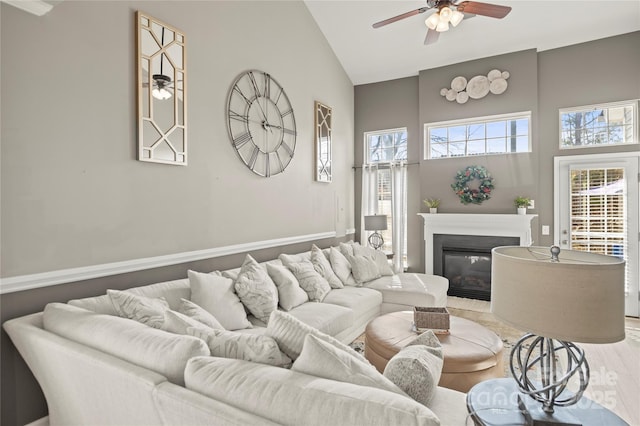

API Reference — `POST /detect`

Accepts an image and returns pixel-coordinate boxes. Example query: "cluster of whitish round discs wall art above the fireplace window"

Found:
[440,69,510,104]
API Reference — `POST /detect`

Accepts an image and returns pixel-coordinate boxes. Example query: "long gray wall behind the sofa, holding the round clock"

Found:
[0,1,354,425]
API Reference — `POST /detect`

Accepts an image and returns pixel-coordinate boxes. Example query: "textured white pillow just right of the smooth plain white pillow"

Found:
[234,254,278,323]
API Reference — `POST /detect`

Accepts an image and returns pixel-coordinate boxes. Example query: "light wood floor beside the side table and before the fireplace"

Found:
[448,297,640,426]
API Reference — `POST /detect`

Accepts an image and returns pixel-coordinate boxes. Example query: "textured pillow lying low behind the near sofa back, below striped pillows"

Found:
[187,327,291,368]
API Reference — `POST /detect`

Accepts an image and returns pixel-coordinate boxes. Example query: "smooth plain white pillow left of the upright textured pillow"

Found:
[188,271,252,330]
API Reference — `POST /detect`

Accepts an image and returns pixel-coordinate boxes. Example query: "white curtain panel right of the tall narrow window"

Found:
[391,161,407,272]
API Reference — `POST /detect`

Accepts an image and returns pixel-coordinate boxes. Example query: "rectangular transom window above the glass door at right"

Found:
[560,101,638,149]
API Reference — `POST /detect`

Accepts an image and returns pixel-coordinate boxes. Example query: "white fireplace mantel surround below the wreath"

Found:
[418,213,538,274]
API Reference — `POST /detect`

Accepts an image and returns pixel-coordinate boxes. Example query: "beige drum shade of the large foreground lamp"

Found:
[491,246,625,343]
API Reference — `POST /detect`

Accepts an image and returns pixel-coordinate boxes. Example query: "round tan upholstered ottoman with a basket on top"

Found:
[364,311,504,392]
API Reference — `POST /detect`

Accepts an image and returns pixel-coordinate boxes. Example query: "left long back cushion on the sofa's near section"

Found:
[43,303,209,385]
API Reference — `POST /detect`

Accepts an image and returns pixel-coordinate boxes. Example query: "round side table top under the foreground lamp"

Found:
[467,378,629,426]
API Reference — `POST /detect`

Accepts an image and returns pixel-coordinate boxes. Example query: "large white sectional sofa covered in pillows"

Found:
[4,243,467,425]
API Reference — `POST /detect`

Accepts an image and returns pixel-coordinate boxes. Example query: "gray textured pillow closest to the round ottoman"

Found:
[383,331,443,405]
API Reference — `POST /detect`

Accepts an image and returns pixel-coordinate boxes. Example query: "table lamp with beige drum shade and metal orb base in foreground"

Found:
[491,246,625,424]
